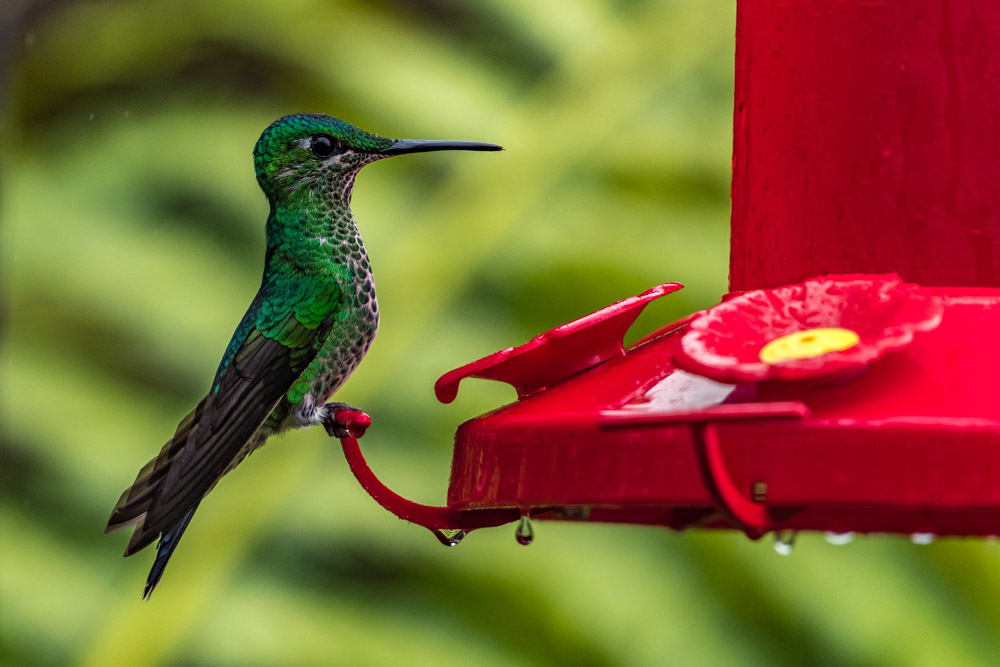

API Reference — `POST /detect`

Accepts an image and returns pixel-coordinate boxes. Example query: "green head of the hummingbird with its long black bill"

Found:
[253,113,502,201]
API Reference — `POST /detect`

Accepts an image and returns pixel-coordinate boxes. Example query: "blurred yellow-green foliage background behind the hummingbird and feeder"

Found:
[0,0,1000,666]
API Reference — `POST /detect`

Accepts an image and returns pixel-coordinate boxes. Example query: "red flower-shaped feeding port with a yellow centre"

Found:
[674,274,943,384]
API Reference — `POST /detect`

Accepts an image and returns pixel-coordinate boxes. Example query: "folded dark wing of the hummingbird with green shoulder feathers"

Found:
[106,282,339,556]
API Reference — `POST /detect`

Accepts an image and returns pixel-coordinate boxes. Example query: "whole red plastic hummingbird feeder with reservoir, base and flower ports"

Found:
[344,0,1000,543]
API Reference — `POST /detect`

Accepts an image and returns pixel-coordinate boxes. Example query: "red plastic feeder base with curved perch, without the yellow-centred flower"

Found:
[342,285,1000,537]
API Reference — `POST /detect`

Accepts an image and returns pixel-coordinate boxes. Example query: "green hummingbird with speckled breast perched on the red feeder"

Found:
[105,114,502,598]
